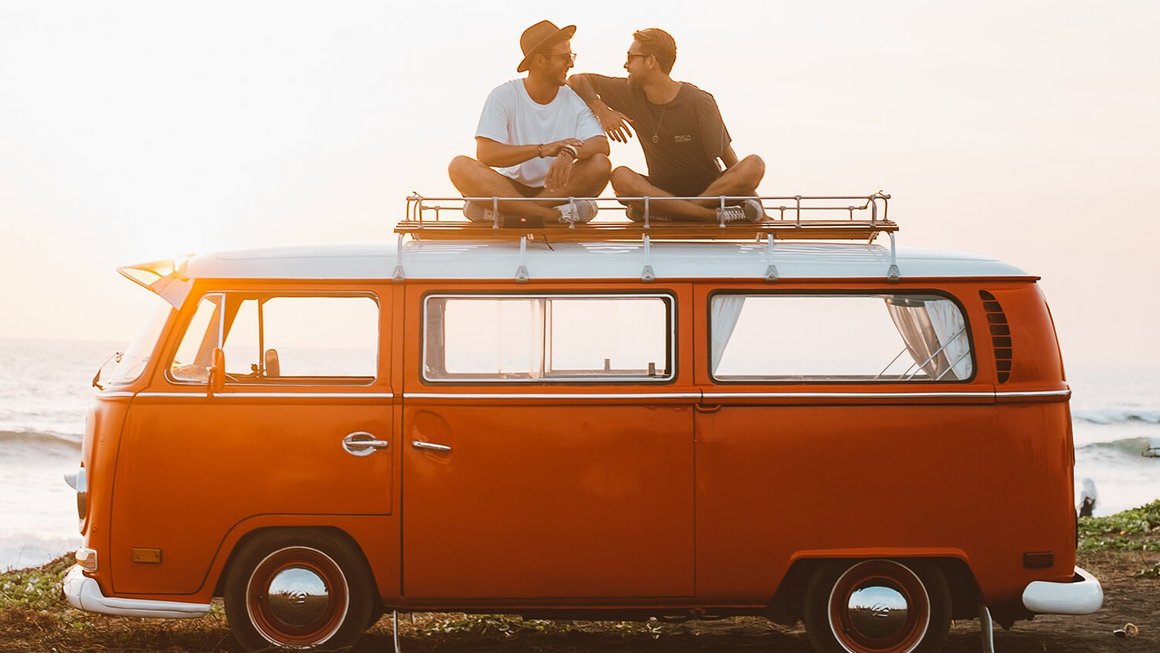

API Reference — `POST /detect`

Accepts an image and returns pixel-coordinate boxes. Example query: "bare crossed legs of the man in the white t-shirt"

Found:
[447,154,612,219]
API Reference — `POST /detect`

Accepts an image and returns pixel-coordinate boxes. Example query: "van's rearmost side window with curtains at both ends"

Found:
[710,293,974,383]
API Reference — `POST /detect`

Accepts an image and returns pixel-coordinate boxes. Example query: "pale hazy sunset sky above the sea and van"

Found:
[0,0,1160,367]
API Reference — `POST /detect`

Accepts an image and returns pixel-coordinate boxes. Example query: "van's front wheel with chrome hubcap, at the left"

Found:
[225,530,376,651]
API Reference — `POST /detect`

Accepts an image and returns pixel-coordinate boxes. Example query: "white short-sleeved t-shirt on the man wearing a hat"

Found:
[476,78,604,187]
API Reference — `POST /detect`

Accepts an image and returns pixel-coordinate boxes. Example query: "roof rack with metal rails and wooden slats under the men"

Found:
[394,190,898,247]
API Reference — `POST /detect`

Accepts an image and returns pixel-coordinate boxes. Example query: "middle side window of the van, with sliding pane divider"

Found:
[423,295,674,382]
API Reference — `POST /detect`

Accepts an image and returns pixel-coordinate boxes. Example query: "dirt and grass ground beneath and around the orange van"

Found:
[0,551,1160,653]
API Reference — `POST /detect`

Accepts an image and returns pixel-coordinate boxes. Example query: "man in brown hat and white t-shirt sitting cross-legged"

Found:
[448,21,611,223]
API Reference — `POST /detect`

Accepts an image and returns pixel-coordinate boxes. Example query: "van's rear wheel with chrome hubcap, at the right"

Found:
[802,559,951,653]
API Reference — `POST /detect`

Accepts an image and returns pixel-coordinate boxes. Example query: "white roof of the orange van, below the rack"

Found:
[177,240,1035,280]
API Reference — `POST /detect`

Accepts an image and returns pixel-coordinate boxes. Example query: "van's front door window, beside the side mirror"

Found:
[169,292,378,384]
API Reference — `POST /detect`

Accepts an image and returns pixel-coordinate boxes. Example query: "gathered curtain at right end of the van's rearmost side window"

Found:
[886,297,971,380]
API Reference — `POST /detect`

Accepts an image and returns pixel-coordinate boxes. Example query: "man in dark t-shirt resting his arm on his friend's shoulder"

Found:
[568,28,766,222]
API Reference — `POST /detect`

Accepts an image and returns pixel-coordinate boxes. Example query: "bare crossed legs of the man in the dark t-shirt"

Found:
[612,154,766,222]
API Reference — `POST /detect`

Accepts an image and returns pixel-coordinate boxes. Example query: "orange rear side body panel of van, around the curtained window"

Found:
[682,281,1074,603]
